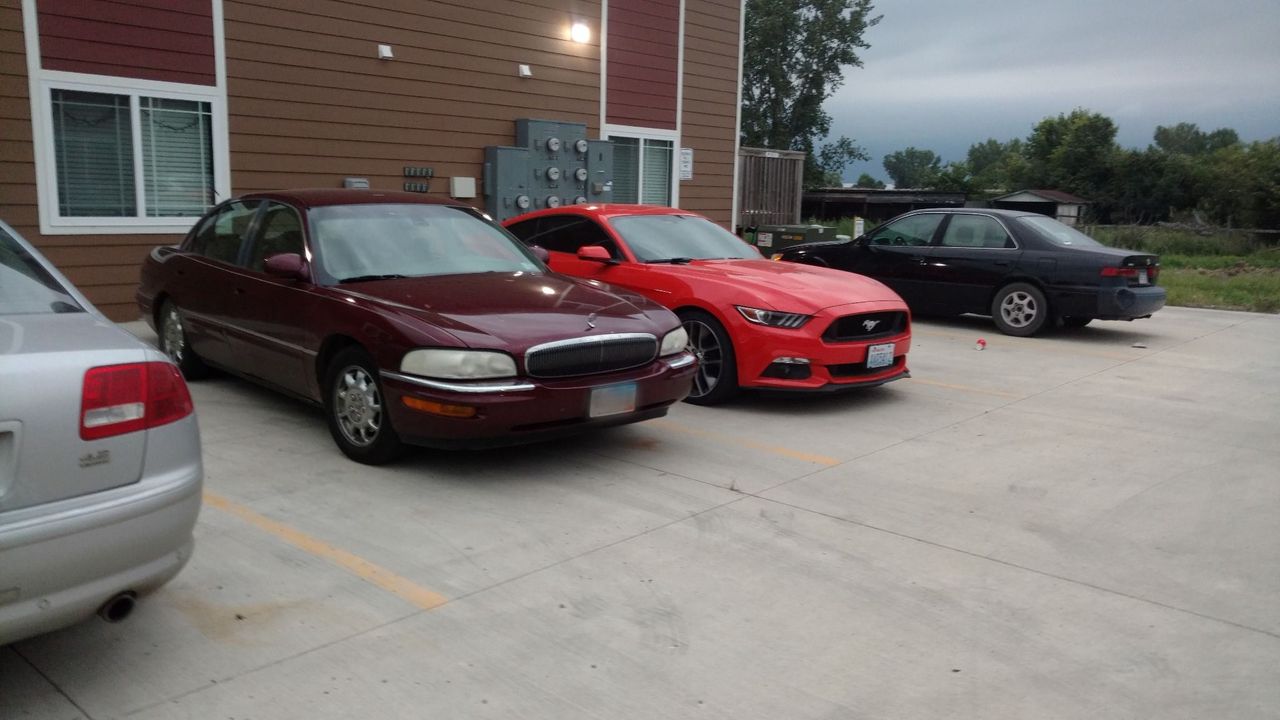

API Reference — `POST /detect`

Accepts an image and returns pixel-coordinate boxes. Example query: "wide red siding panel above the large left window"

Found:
[36,0,216,85]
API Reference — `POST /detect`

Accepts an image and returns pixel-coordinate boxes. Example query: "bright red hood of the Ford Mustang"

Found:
[654,260,905,313]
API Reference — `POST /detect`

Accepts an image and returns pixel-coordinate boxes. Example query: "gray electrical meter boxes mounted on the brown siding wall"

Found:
[484,119,613,220]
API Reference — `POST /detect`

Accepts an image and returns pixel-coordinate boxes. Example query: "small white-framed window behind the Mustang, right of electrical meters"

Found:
[605,126,680,206]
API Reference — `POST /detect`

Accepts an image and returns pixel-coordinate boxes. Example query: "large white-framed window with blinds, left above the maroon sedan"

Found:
[32,72,230,234]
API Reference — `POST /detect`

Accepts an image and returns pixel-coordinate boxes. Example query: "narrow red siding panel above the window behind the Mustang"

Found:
[605,0,680,129]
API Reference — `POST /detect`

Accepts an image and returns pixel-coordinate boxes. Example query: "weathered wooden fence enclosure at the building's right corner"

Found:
[735,147,805,228]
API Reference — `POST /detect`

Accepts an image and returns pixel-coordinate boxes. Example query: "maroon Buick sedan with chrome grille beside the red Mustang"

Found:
[137,190,695,464]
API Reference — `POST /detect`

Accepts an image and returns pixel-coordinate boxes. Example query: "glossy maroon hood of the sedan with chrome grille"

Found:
[333,273,680,354]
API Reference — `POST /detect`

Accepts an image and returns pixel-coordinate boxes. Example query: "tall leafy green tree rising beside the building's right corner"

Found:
[742,0,879,187]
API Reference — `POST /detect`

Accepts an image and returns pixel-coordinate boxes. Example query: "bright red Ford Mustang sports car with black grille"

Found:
[504,205,911,405]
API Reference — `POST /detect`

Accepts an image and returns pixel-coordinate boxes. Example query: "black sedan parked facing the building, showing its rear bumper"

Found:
[773,209,1165,337]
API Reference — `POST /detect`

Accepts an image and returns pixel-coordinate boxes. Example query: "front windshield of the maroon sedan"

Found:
[311,204,545,282]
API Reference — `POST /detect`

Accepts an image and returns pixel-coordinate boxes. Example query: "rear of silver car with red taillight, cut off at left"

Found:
[0,223,204,646]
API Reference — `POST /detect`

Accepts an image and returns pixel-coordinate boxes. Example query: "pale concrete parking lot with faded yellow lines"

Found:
[0,307,1280,720]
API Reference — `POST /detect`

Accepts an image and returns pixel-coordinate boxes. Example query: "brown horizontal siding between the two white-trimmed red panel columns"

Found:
[225,0,600,193]
